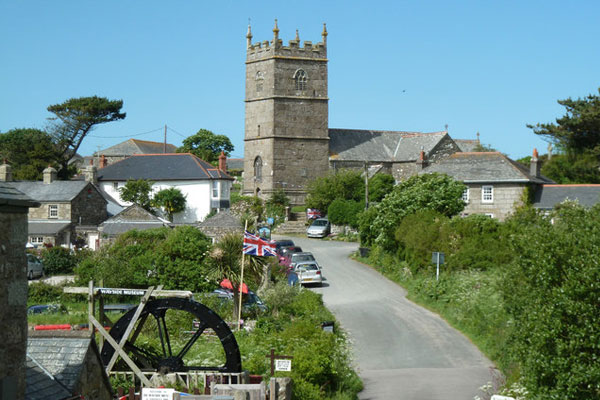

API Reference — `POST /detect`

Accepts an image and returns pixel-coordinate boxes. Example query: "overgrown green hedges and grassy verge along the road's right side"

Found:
[358,203,600,399]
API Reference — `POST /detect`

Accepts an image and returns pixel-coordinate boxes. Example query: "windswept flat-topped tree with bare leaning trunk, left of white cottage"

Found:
[48,96,126,178]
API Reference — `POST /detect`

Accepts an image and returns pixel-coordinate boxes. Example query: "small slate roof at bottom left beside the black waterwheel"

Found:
[27,331,92,399]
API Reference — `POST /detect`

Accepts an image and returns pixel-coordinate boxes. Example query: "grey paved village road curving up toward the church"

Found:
[284,237,493,400]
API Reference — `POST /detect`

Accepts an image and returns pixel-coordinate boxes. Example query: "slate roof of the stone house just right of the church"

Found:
[421,152,553,184]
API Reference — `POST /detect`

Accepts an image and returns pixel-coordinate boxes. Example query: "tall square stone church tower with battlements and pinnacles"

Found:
[243,20,329,204]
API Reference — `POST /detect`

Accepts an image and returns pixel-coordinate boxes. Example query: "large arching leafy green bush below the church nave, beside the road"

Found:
[360,173,466,250]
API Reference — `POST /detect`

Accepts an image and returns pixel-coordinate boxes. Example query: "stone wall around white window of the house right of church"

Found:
[463,183,526,221]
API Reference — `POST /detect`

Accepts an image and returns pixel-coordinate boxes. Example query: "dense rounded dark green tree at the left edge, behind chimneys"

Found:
[0,129,59,181]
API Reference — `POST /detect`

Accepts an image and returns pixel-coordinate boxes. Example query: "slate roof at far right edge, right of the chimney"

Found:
[533,185,600,210]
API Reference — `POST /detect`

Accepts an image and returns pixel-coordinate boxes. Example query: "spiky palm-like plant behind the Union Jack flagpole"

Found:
[210,233,269,319]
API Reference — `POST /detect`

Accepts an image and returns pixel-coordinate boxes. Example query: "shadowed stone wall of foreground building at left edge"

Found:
[0,206,27,400]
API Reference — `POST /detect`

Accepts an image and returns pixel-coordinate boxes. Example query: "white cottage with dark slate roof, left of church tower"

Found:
[98,153,233,224]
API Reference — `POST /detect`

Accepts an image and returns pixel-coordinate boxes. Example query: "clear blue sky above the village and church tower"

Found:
[0,0,600,158]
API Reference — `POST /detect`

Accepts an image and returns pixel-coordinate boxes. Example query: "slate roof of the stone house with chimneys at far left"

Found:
[4,181,89,202]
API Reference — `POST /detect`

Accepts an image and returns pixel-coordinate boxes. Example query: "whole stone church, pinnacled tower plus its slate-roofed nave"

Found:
[243,20,472,204]
